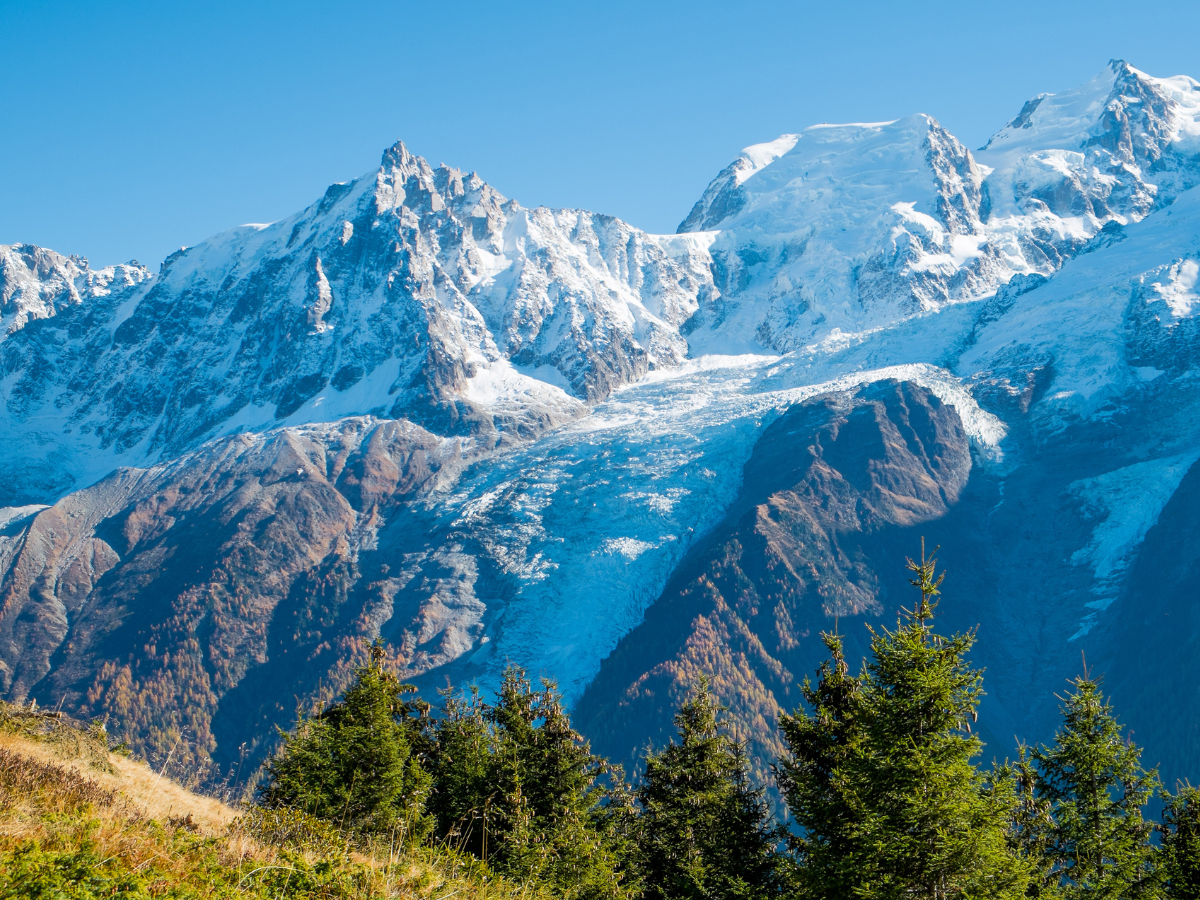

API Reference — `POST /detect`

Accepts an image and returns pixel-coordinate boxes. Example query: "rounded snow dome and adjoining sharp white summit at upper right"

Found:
[679,61,1200,353]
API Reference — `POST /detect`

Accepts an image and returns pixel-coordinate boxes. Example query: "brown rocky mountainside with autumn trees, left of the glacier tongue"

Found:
[0,419,478,764]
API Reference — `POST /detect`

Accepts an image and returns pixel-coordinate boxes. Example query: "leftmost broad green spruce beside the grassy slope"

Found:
[262,642,432,841]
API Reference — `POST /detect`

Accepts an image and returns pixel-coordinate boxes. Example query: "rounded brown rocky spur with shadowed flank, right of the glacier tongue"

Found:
[577,382,971,764]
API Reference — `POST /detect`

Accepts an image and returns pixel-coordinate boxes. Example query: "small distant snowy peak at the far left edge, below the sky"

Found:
[0,244,150,341]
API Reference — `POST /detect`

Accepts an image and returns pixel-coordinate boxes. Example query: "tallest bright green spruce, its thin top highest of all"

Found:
[863,547,1027,899]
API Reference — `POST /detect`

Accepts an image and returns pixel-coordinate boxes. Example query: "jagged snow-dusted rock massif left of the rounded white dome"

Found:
[0,144,710,502]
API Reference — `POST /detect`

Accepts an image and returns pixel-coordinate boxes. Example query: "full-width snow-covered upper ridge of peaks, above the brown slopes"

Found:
[7,62,1200,508]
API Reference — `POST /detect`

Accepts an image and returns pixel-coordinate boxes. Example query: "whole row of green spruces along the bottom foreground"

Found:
[259,550,1200,900]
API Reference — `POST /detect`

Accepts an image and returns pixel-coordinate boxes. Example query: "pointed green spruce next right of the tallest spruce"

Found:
[1032,674,1158,900]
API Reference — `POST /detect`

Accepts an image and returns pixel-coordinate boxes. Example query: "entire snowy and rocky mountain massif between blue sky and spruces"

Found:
[0,61,1200,780]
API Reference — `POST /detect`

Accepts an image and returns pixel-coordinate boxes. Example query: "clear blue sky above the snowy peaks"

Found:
[7,0,1200,268]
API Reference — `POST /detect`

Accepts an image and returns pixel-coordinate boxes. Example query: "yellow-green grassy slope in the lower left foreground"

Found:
[0,704,539,900]
